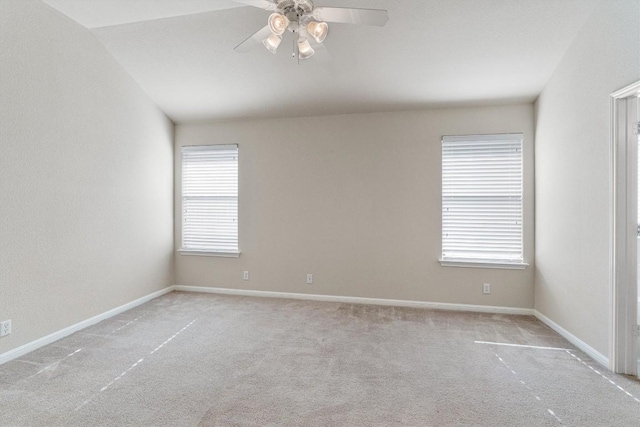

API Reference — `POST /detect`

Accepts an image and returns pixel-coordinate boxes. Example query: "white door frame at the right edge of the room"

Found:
[609,81,640,375]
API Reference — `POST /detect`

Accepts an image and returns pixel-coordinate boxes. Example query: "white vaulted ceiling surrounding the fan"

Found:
[44,0,599,123]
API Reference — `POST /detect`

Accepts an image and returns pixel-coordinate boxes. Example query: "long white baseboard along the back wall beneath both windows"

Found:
[173,285,533,316]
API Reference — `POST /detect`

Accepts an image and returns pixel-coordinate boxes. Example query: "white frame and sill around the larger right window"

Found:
[438,133,529,270]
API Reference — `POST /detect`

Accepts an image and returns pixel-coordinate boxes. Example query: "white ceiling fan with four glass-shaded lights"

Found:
[235,0,389,60]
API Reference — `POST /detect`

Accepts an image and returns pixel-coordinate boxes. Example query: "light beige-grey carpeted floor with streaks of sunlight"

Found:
[0,292,640,427]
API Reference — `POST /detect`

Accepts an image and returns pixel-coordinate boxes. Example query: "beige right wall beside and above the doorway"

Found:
[535,0,640,355]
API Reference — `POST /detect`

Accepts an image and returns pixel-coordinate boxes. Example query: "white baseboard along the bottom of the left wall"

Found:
[0,286,174,365]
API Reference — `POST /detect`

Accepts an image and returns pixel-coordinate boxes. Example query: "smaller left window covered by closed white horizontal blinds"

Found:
[180,145,240,256]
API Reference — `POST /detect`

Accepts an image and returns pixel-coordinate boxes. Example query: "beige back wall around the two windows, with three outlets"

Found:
[175,105,533,308]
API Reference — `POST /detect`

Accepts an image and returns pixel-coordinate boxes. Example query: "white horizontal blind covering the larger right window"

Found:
[442,134,523,263]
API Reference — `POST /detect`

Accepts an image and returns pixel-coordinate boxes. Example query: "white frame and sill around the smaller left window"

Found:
[178,144,241,258]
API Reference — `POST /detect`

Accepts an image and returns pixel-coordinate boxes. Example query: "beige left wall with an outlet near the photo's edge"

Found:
[0,0,173,354]
